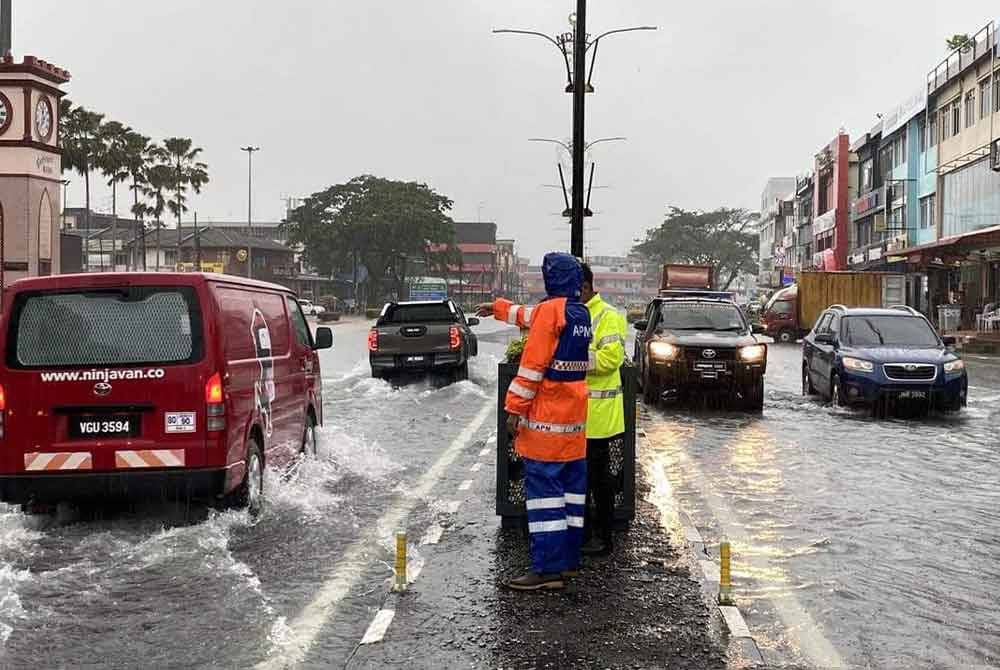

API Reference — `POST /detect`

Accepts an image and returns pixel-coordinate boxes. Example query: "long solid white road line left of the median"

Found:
[257,401,493,670]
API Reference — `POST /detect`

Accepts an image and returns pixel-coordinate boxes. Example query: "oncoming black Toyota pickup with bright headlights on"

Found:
[635,291,767,412]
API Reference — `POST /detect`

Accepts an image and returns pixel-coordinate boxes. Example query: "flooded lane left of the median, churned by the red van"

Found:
[0,322,516,668]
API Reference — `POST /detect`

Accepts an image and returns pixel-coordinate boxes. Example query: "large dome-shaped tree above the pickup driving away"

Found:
[285,175,455,306]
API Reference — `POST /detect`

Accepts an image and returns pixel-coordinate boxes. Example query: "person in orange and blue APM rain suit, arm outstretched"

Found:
[477,253,591,591]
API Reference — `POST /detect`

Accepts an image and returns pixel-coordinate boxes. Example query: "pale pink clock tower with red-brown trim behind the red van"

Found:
[0,54,69,287]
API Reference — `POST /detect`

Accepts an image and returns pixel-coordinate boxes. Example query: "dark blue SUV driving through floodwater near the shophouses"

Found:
[802,305,969,412]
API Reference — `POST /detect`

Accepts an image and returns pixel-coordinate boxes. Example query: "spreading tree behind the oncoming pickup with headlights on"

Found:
[634,206,759,291]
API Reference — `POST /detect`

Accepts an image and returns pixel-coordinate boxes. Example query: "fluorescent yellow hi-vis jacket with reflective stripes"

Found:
[587,295,626,439]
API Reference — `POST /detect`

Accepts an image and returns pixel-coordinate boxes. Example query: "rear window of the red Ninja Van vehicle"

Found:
[7,286,202,368]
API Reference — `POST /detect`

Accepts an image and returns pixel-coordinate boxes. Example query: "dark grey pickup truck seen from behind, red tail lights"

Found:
[368,300,479,381]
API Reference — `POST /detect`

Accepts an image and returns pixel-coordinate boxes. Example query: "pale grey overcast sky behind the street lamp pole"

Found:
[19,0,1000,266]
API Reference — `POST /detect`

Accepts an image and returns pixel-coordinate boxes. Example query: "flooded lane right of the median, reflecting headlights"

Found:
[641,345,1000,669]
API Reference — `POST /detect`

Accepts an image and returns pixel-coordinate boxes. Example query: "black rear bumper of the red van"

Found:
[0,468,226,505]
